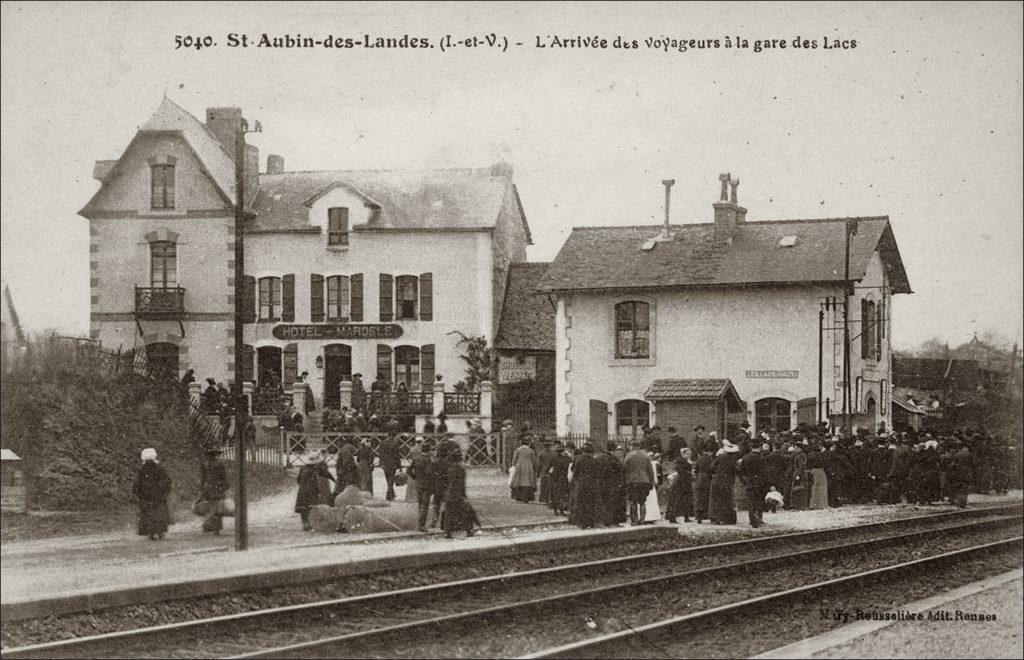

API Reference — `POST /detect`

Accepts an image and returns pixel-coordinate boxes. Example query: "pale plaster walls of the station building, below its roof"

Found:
[555,252,892,435]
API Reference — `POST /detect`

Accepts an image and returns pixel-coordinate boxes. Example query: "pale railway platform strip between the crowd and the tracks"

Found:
[0,478,1021,612]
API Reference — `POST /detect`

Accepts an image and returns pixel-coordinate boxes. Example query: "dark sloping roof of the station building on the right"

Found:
[539,216,910,294]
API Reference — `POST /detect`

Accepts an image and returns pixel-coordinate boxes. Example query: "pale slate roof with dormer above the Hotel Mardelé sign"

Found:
[247,168,529,235]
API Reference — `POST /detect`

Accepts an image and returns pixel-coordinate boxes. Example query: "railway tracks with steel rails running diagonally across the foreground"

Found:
[2,504,1021,658]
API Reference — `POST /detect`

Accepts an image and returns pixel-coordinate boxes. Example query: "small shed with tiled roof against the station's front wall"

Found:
[644,379,746,438]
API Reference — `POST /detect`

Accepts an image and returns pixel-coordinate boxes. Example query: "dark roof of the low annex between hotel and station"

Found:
[495,263,555,351]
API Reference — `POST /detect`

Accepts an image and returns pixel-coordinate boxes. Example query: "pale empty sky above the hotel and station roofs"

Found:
[0,2,1024,349]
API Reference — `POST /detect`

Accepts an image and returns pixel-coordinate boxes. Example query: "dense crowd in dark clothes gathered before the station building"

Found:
[501,423,1020,528]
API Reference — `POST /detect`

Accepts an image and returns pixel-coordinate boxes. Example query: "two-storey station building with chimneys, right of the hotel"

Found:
[539,175,911,438]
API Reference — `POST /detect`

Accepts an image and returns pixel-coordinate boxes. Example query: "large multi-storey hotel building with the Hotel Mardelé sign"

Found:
[80,98,530,406]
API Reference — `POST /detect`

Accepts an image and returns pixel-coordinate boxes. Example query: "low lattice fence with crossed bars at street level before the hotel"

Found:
[282,431,506,466]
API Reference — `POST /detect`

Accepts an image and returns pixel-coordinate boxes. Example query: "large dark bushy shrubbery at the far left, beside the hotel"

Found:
[0,343,211,511]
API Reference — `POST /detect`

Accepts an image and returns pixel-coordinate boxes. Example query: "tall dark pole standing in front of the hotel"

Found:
[231,119,261,551]
